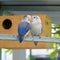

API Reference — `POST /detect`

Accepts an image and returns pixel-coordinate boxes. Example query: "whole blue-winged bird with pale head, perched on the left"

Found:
[18,15,31,43]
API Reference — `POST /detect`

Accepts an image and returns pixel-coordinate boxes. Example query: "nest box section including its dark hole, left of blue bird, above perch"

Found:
[0,16,23,34]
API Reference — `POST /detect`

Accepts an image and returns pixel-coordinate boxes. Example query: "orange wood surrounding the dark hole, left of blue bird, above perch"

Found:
[0,16,21,34]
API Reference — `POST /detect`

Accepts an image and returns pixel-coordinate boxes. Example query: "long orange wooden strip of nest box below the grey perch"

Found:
[0,40,52,49]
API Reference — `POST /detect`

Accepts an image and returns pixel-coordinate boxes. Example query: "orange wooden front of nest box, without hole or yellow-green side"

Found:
[0,14,52,49]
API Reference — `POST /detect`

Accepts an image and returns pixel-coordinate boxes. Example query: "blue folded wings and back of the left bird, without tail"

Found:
[18,22,30,35]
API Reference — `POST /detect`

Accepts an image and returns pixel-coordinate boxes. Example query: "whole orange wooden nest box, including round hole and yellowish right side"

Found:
[0,14,52,49]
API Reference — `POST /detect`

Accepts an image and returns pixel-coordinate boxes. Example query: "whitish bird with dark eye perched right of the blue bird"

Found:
[31,15,42,46]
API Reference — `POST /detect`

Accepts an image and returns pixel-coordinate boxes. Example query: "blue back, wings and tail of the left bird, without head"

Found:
[18,22,30,43]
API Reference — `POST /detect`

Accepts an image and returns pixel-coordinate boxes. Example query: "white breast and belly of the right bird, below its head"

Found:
[31,23,42,36]
